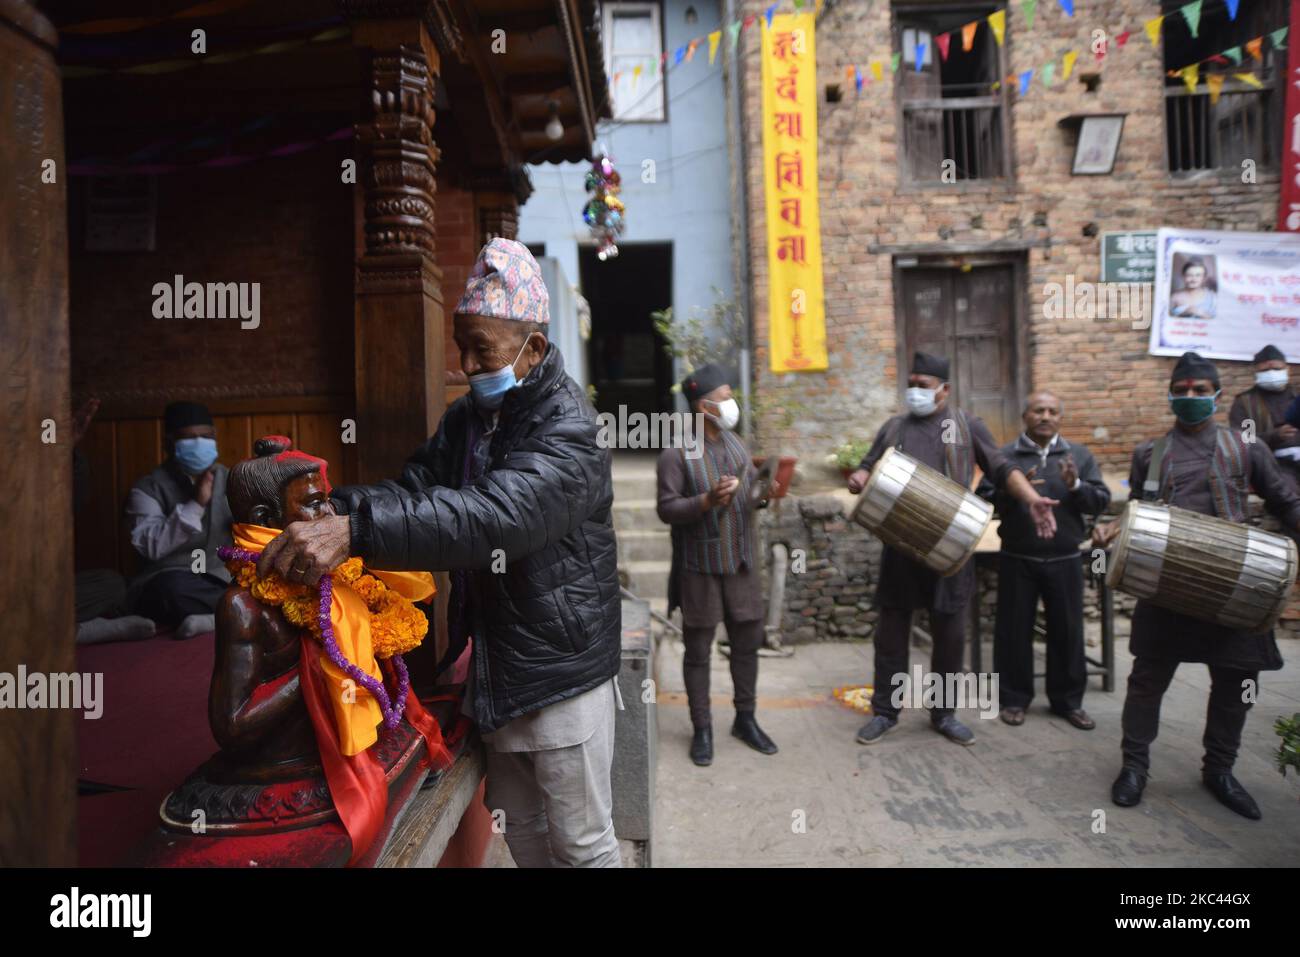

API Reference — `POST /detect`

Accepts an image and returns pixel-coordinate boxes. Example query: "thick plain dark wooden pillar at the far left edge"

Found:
[0,0,76,867]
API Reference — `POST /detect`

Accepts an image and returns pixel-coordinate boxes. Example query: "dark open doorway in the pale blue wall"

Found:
[579,243,672,416]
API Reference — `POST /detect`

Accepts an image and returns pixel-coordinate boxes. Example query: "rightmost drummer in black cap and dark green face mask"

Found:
[1093,352,1300,820]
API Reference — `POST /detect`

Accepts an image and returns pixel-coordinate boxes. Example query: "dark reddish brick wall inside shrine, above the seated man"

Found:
[69,143,354,407]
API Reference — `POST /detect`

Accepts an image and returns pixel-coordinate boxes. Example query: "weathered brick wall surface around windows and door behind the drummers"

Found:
[742,0,1278,468]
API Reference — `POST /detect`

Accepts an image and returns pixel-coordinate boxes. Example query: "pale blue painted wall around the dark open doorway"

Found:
[519,0,732,397]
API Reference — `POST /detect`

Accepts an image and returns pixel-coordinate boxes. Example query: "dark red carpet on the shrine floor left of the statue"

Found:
[77,633,217,867]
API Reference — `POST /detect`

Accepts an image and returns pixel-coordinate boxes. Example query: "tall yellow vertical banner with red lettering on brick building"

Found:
[763,10,827,372]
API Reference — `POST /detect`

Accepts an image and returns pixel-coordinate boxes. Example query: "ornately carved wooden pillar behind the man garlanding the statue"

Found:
[343,11,446,481]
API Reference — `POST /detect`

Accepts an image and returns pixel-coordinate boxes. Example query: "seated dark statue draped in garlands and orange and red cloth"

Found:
[161,436,450,861]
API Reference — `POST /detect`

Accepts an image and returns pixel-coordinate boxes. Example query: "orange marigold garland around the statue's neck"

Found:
[226,558,429,659]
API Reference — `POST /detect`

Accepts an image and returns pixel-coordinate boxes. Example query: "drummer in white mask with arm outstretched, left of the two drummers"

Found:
[849,352,1060,745]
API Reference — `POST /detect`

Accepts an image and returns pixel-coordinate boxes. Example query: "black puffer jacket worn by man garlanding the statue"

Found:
[334,345,621,731]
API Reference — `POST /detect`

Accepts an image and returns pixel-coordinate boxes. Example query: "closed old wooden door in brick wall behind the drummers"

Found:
[900,264,1021,443]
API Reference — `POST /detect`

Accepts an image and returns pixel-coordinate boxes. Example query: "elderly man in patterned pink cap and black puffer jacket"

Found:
[259,239,621,867]
